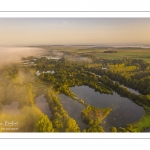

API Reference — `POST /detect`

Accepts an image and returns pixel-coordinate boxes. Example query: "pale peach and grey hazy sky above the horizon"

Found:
[0,18,150,46]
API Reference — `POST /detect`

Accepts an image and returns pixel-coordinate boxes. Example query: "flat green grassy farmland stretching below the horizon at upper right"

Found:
[41,46,150,63]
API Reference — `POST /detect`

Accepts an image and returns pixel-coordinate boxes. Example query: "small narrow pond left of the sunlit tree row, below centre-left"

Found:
[36,94,52,118]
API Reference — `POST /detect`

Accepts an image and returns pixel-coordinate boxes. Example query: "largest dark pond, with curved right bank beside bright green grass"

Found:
[68,86,144,132]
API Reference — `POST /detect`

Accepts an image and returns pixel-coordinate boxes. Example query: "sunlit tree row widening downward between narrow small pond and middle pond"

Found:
[45,88,80,132]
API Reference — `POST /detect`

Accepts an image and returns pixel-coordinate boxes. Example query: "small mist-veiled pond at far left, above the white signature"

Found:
[1,101,20,115]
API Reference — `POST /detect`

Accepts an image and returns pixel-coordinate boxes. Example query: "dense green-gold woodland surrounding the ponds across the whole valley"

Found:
[0,51,150,132]
